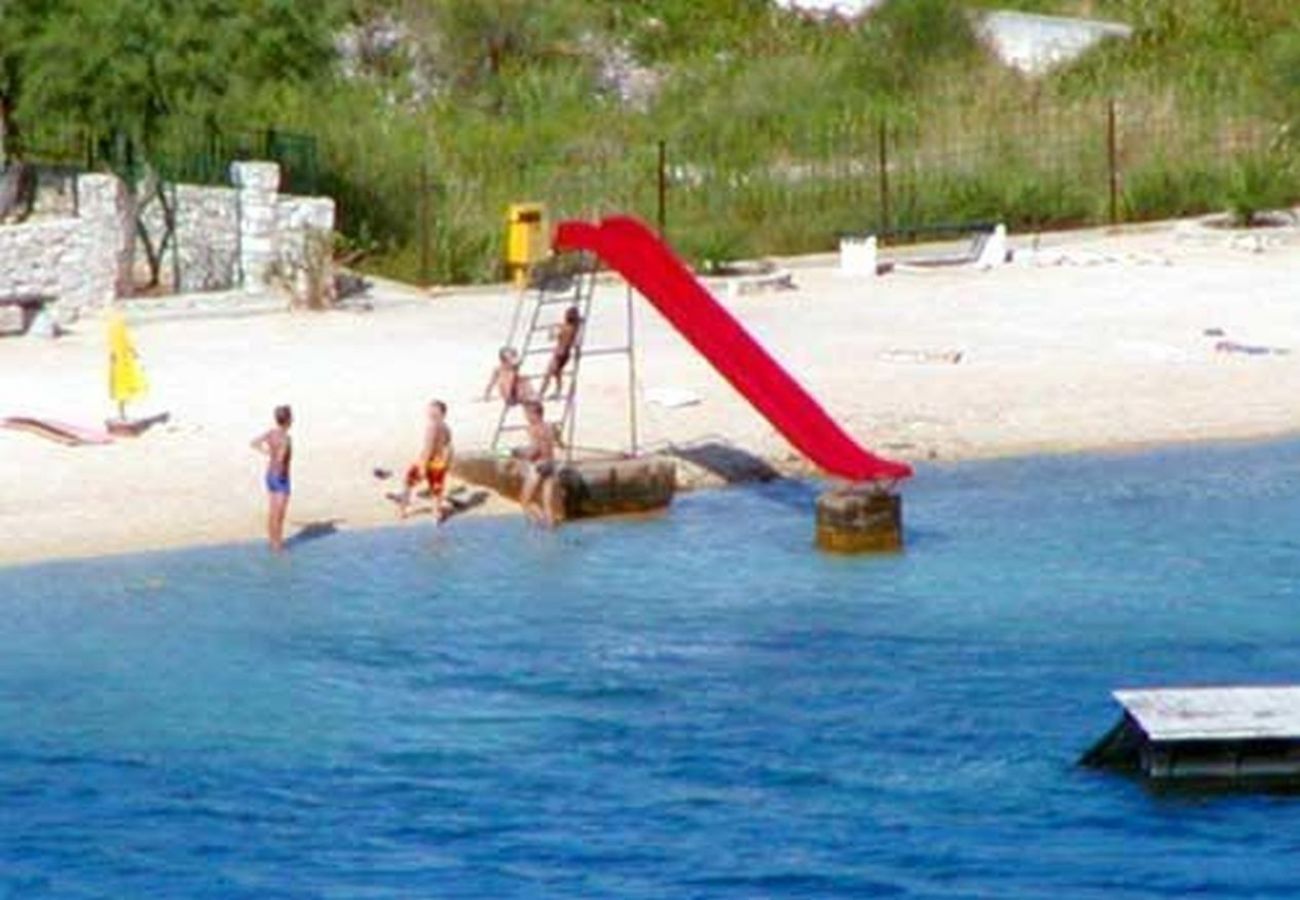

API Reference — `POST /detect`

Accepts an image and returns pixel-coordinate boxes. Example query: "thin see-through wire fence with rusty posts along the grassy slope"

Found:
[337,87,1300,282]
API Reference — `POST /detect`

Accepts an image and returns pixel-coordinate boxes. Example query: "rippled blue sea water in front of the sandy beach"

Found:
[0,443,1300,900]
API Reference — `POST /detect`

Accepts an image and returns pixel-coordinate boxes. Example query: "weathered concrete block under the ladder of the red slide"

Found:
[452,453,677,520]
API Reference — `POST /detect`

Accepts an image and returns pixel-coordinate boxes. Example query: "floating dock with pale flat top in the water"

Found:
[1080,685,1300,786]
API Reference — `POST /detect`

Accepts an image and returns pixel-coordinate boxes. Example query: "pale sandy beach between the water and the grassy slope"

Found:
[0,222,1300,564]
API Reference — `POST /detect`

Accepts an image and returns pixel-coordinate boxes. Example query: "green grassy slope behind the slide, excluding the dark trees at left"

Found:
[278,0,1300,282]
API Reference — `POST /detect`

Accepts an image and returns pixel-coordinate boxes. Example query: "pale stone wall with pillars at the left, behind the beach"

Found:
[0,163,334,315]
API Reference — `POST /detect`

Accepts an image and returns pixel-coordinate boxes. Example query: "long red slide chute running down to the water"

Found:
[554,216,911,481]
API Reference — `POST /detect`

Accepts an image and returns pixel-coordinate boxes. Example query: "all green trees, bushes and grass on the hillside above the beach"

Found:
[0,0,1300,281]
